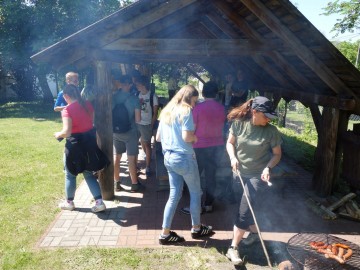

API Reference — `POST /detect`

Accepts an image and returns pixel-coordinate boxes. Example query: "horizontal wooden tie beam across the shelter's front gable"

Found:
[103,38,279,55]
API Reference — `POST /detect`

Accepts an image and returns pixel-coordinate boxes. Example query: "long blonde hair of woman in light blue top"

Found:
[160,84,199,125]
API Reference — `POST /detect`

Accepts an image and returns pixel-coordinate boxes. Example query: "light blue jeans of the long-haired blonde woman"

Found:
[162,151,202,229]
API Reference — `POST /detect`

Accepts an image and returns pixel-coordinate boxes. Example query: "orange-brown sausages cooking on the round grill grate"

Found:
[309,241,353,264]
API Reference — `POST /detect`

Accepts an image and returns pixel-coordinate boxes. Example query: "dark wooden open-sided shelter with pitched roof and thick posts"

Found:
[32,0,360,199]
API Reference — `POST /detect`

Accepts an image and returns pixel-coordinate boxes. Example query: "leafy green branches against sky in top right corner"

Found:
[324,0,360,34]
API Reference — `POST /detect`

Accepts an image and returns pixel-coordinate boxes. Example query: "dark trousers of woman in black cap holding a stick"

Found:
[234,174,266,230]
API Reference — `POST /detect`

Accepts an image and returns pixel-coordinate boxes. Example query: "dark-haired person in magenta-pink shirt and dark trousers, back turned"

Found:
[181,81,226,214]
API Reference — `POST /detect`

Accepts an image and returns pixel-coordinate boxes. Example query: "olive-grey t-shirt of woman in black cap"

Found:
[230,120,282,176]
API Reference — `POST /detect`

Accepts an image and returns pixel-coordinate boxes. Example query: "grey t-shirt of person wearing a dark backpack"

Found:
[112,90,140,130]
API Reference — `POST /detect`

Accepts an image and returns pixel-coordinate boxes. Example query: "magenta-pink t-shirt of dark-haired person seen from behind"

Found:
[193,99,226,148]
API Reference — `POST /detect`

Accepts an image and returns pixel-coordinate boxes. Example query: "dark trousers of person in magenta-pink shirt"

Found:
[194,145,224,206]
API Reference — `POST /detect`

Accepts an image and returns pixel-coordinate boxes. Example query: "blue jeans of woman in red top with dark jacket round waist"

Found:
[64,155,102,201]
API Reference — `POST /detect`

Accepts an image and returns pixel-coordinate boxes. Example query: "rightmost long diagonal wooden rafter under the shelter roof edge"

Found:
[241,0,356,98]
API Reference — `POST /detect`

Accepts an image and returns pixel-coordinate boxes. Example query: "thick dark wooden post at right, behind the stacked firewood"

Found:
[313,107,339,196]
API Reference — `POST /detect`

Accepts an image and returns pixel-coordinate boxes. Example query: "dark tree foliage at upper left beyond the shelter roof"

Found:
[0,0,121,100]
